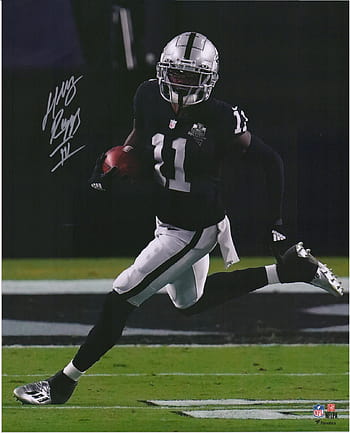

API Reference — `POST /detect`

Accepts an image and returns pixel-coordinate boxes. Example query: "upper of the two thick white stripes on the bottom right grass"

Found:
[145,398,349,404]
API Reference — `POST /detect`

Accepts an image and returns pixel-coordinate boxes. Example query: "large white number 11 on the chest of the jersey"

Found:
[152,133,191,192]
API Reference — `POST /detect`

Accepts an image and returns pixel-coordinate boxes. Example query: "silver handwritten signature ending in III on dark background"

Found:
[41,75,85,172]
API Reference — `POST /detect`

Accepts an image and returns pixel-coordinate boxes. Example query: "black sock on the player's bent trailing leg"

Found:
[179,267,268,315]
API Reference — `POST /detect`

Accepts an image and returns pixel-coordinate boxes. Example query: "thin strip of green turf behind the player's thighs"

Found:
[2,257,349,280]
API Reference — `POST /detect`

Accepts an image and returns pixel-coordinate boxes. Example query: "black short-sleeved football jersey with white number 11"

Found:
[134,80,248,230]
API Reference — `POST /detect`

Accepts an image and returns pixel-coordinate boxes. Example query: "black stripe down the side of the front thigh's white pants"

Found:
[119,230,203,299]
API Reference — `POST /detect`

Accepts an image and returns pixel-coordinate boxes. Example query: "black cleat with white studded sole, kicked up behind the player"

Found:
[277,242,344,296]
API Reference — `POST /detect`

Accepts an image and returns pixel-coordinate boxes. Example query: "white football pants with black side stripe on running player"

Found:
[113,218,238,308]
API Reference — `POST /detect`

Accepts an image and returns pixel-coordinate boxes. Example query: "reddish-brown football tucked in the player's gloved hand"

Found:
[102,146,139,178]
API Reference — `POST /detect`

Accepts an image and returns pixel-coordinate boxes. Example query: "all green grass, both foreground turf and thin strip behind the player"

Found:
[2,257,349,432]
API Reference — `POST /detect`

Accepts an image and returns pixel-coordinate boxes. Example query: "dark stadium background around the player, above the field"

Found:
[2,0,349,257]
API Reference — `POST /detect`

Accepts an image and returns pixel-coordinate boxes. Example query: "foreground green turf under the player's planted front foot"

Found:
[2,345,349,432]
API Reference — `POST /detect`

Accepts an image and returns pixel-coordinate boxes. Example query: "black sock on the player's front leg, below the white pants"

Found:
[73,290,136,371]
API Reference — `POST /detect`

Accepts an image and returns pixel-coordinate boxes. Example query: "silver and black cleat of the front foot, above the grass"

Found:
[13,371,78,405]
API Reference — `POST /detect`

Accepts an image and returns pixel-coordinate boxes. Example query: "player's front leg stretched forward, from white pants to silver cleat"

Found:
[14,221,217,405]
